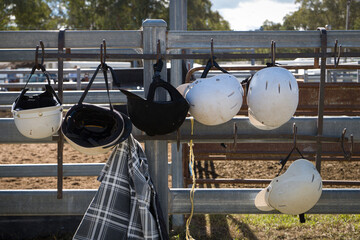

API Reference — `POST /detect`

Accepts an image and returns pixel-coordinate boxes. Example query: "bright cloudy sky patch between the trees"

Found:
[211,0,299,31]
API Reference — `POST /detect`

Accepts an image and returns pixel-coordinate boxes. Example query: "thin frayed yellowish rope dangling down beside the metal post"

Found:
[186,118,196,240]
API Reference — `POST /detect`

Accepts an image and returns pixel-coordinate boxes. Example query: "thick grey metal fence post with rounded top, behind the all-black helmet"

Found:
[143,19,169,227]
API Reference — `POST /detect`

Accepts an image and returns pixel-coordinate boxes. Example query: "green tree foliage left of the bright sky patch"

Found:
[0,0,230,30]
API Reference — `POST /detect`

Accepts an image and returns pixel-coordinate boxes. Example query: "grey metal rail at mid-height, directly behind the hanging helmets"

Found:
[0,116,360,143]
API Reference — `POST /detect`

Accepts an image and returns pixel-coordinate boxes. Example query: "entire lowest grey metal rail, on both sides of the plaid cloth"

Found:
[0,188,360,216]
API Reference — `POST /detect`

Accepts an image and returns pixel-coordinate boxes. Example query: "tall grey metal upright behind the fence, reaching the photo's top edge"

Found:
[170,0,187,227]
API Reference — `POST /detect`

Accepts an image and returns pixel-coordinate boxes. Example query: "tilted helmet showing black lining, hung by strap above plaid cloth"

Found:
[61,51,132,155]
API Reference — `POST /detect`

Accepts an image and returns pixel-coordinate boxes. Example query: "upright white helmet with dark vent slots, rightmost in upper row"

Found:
[247,67,299,130]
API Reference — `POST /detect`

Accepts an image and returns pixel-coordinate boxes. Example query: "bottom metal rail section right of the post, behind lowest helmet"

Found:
[169,188,360,214]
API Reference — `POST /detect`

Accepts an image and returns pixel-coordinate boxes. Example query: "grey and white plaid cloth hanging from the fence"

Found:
[73,135,169,240]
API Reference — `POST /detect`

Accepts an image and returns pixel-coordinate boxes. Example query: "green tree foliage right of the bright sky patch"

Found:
[261,0,360,30]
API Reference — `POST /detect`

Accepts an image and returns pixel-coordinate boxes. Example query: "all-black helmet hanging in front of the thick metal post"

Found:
[120,59,189,136]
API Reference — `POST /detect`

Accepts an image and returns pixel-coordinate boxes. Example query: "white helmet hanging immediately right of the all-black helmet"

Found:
[184,74,244,125]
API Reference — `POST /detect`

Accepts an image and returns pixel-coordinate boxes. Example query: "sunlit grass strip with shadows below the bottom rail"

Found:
[170,214,360,240]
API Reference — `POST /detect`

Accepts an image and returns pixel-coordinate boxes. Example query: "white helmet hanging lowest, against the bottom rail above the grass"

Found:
[255,159,322,215]
